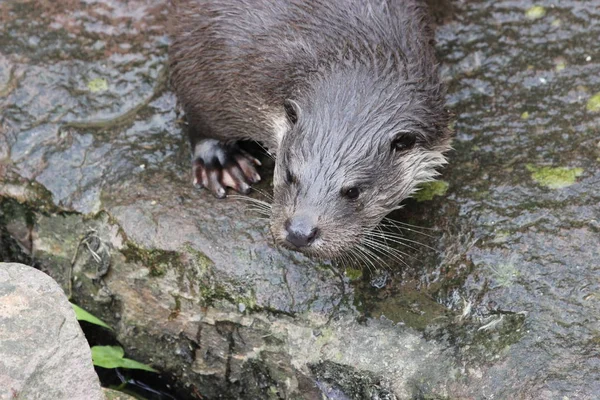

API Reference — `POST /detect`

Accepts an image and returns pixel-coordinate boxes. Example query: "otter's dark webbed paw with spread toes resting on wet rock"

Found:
[192,139,261,199]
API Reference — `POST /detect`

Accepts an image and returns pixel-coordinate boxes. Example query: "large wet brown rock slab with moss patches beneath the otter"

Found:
[0,0,600,399]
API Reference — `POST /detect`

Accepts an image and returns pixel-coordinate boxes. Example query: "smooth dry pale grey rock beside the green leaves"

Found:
[0,263,104,400]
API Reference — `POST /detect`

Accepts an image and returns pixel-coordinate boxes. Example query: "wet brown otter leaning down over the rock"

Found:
[169,0,451,259]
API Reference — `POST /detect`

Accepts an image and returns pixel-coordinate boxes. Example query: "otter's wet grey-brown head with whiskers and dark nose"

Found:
[271,70,450,259]
